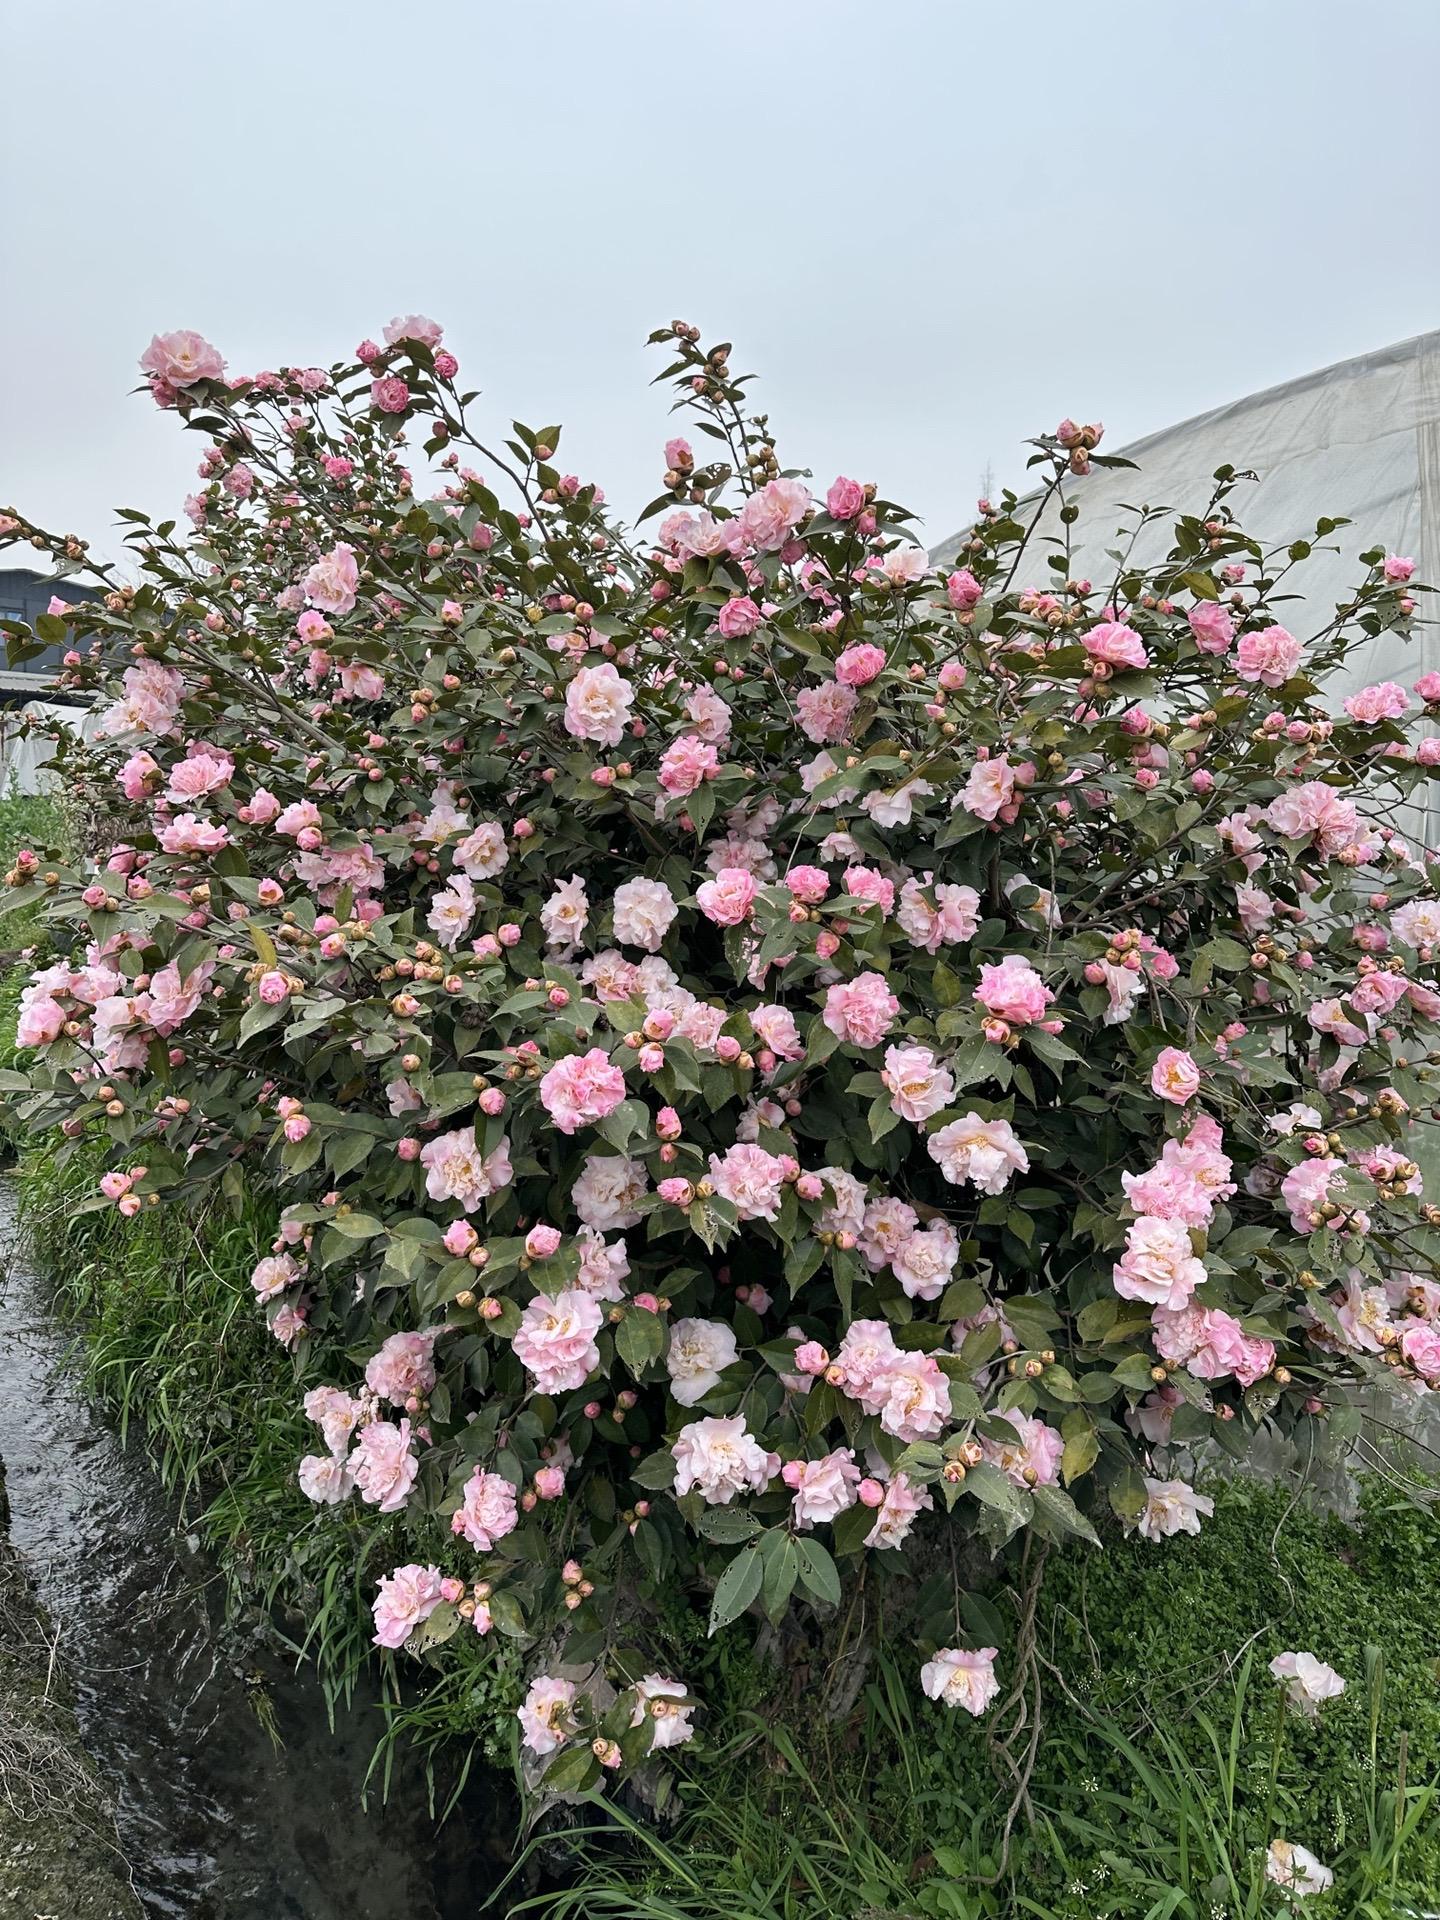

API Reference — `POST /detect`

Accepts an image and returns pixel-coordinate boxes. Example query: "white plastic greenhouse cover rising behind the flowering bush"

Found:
[935,332,1440,714]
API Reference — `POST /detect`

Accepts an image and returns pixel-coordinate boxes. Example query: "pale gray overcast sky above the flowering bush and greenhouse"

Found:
[0,0,1440,553]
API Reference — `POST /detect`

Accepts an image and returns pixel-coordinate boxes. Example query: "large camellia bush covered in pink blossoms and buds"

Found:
[0,317,1440,1789]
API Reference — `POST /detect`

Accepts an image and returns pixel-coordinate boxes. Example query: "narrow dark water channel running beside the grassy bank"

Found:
[0,1177,507,1920]
